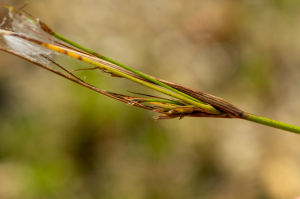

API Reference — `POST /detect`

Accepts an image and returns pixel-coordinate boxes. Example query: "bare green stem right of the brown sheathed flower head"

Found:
[243,113,300,134]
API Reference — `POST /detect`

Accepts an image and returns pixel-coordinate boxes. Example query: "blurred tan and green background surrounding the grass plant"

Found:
[0,0,300,199]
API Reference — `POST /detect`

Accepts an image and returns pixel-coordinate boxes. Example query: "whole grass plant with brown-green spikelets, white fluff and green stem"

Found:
[0,3,300,134]
